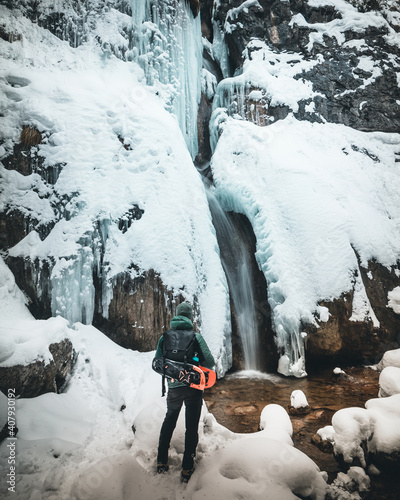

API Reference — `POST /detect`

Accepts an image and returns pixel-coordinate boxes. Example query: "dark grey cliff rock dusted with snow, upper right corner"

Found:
[214,0,400,132]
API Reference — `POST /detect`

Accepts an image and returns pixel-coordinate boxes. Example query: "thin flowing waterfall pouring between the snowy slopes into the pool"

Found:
[206,186,261,370]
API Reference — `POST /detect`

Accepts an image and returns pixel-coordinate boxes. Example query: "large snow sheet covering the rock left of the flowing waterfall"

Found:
[0,2,231,374]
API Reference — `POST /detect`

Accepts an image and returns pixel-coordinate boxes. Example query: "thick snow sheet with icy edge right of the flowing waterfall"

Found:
[211,113,400,376]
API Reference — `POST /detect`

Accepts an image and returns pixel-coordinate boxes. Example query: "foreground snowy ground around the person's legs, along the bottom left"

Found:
[0,320,326,500]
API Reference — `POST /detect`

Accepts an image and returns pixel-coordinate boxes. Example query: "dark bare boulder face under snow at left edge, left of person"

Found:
[0,339,75,398]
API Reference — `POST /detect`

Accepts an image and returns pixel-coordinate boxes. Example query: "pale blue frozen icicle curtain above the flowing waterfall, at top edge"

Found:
[131,0,203,158]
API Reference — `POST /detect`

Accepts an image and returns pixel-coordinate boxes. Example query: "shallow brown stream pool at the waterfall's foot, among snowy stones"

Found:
[204,367,399,500]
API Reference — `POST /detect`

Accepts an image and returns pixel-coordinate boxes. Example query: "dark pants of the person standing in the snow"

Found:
[157,387,203,470]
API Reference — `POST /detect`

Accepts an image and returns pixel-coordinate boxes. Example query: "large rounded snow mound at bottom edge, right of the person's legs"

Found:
[189,437,326,500]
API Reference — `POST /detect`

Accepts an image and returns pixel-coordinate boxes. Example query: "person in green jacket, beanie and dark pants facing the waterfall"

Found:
[156,302,214,483]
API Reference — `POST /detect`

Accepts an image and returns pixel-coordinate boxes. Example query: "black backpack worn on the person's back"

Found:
[162,330,199,396]
